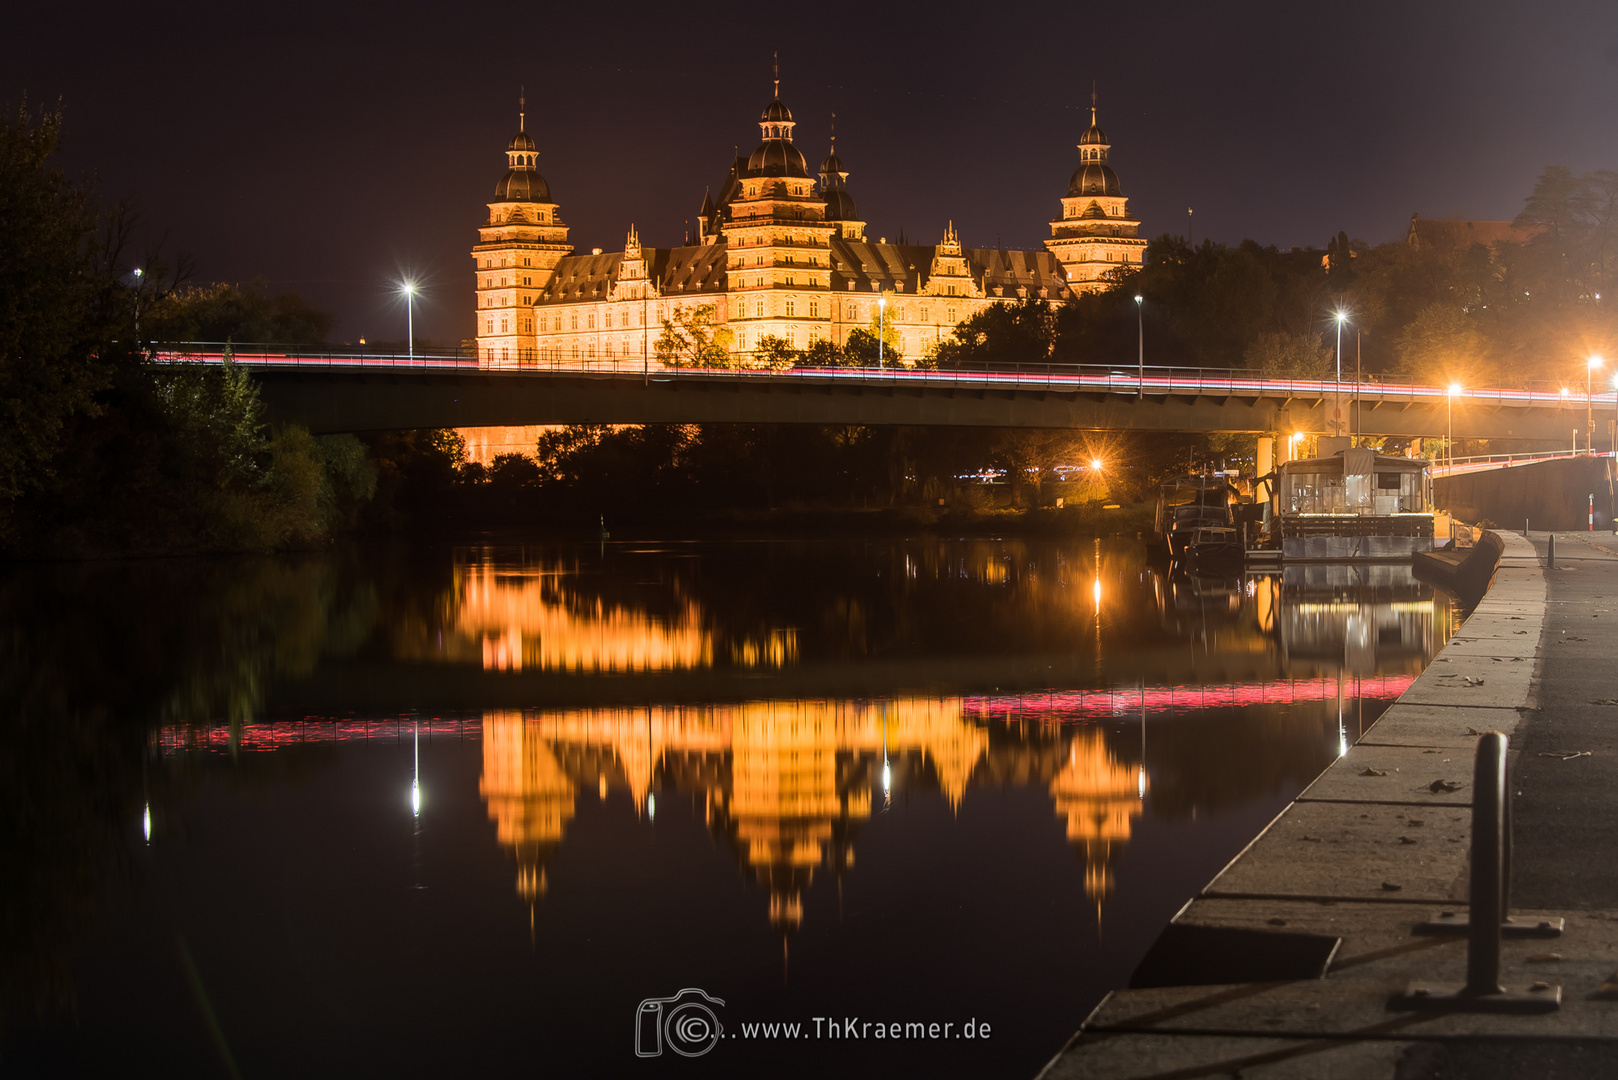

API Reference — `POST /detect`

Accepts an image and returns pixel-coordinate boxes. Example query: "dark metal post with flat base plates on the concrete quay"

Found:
[1388,732,1563,1012]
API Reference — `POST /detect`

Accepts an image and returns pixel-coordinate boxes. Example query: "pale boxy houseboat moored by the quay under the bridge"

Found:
[1265,449,1434,562]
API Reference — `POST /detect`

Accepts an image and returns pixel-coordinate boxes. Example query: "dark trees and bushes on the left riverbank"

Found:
[0,104,375,557]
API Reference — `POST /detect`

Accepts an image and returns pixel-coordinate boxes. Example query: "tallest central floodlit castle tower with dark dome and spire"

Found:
[720,62,837,351]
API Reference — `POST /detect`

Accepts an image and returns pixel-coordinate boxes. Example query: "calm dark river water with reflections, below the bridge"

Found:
[0,541,1455,1077]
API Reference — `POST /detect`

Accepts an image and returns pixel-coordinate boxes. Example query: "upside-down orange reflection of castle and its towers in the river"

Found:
[481,698,1146,928]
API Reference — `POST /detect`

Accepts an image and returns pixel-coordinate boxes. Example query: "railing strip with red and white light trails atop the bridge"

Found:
[150,342,1618,410]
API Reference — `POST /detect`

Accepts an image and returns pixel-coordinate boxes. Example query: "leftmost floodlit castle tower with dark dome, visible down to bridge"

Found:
[472,99,573,368]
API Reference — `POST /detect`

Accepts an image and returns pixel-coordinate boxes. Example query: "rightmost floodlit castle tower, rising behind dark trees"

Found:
[1045,94,1146,293]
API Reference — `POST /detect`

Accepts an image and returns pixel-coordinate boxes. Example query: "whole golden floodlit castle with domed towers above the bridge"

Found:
[472,79,1146,368]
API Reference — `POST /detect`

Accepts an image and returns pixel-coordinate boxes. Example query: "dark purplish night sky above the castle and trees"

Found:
[9,0,1618,342]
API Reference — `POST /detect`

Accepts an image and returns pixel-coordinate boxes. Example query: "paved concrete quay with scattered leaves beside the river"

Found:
[1040,533,1618,1080]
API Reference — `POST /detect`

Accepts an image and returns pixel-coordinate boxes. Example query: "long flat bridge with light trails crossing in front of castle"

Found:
[155,347,1618,444]
